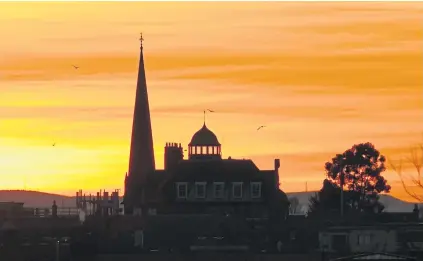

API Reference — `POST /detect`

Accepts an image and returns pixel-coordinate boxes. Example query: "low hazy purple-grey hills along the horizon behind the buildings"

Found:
[0,190,420,212]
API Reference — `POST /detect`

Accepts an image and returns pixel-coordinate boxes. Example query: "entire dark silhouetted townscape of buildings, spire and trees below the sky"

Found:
[0,36,423,261]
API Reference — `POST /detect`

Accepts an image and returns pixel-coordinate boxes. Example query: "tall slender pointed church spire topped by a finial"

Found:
[125,34,155,212]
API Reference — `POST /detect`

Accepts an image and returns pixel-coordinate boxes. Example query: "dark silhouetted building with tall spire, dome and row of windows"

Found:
[123,37,288,219]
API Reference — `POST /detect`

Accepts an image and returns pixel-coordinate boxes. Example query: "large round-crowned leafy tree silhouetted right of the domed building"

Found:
[325,142,391,211]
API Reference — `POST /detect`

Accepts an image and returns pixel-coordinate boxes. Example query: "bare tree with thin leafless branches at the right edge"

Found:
[389,144,423,202]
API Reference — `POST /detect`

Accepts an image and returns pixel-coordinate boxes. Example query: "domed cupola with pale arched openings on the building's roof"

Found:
[188,123,222,160]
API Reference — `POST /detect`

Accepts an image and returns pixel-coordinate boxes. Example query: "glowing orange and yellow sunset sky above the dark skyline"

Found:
[0,2,423,199]
